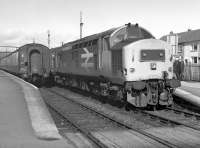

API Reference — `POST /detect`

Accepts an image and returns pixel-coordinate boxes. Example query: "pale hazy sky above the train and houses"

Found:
[0,0,200,48]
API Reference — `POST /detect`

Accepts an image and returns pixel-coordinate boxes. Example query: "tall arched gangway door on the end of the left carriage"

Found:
[30,50,42,75]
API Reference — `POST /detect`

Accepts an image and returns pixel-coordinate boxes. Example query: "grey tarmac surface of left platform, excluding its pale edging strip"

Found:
[0,71,72,148]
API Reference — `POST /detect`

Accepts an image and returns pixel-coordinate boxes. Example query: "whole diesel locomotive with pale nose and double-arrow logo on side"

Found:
[51,24,180,107]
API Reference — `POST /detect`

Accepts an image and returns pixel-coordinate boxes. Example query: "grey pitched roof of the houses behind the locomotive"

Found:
[160,29,200,43]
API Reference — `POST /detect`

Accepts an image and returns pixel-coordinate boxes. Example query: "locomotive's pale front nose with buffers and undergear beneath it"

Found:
[122,39,180,107]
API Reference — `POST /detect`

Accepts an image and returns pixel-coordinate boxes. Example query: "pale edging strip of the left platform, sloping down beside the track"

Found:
[1,70,61,140]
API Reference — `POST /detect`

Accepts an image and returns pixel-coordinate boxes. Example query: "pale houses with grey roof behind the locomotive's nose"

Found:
[161,29,200,64]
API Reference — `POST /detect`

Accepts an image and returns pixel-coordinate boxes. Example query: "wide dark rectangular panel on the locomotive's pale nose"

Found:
[140,49,165,62]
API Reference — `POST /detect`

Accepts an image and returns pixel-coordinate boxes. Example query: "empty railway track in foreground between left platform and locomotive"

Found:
[41,89,178,148]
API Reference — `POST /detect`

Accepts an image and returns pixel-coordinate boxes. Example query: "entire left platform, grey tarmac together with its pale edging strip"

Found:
[0,70,73,148]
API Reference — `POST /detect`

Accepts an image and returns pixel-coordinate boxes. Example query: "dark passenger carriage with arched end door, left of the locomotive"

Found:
[1,43,50,85]
